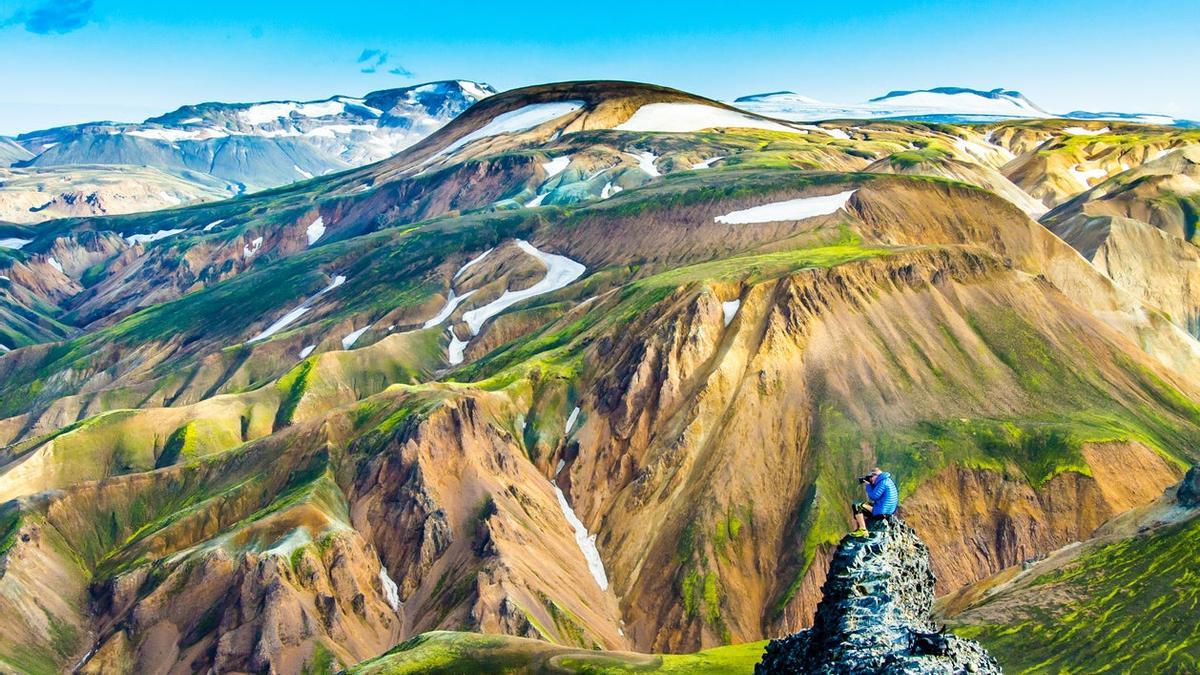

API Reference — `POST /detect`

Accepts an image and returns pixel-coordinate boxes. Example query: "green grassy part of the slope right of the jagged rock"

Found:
[955,518,1200,673]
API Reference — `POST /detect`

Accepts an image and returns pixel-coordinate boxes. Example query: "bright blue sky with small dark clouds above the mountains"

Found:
[0,0,1200,135]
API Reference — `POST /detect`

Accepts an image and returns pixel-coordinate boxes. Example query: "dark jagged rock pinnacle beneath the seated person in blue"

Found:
[755,519,1001,675]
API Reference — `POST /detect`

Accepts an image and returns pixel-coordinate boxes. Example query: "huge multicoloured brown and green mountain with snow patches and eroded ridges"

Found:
[0,82,1200,673]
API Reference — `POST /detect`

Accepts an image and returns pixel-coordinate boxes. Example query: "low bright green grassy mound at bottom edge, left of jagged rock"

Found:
[348,631,767,675]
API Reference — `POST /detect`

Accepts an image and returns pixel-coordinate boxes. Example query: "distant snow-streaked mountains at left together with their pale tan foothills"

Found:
[0,80,496,222]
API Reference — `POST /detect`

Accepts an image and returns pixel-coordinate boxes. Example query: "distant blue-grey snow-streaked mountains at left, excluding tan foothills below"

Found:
[0,80,496,217]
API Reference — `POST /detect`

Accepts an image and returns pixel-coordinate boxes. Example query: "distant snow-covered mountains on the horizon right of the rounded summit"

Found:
[733,86,1195,127]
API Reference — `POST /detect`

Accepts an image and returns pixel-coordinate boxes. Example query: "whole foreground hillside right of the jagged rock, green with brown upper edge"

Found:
[937,467,1200,673]
